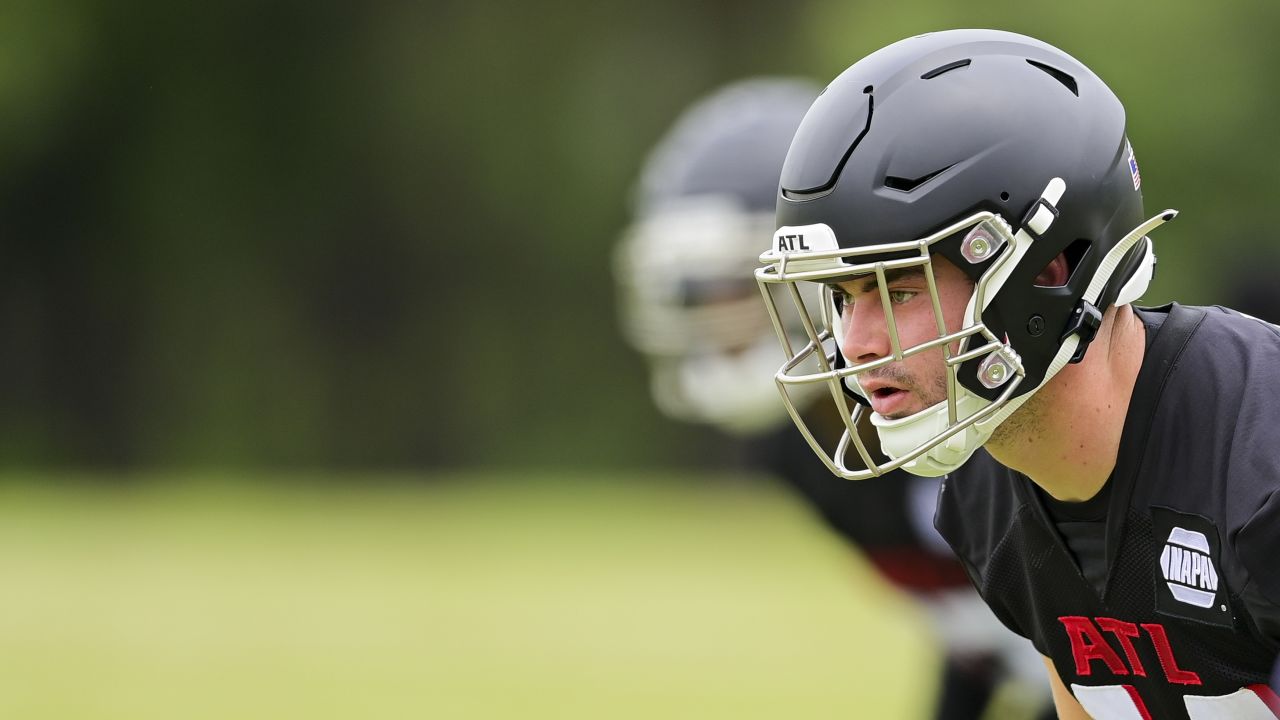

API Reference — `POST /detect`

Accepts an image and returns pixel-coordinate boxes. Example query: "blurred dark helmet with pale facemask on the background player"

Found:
[614,78,818,433]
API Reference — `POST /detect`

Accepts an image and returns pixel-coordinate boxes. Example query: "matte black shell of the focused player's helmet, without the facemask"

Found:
[777,29,1143,398]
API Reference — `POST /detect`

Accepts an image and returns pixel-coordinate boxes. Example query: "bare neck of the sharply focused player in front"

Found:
[987,306,1146,501]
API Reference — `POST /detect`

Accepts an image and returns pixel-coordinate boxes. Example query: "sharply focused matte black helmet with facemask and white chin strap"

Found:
[756,29,1172,478]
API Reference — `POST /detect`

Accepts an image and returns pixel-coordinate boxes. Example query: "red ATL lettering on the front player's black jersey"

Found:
[1057,615,1201,685]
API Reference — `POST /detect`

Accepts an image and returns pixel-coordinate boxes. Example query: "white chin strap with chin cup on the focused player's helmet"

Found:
[875,210,1178,478]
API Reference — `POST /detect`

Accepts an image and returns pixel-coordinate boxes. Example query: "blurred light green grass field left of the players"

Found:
[0,475,936,720]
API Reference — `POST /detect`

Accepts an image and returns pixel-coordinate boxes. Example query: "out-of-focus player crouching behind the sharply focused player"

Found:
[616,79,1051,720]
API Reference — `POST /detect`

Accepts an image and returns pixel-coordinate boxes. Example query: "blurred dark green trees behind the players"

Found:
[0,0,1280,468]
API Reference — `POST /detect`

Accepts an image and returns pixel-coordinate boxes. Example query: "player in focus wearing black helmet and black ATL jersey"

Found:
[756,29,1280,720]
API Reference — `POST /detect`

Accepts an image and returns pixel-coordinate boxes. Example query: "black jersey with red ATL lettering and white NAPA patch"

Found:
[936,305,1280,720]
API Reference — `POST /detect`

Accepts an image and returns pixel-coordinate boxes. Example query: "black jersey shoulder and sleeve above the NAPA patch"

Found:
[1135,306,1280,642]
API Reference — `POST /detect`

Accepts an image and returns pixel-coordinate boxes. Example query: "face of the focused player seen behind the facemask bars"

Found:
[833,258,973,419]
